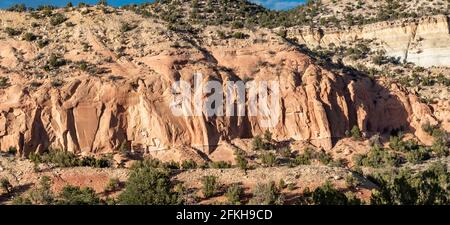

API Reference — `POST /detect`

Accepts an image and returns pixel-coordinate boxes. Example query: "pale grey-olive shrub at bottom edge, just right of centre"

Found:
[249,181,284,205]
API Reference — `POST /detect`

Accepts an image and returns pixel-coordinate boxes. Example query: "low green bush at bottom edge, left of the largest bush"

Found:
[56,185,100,205]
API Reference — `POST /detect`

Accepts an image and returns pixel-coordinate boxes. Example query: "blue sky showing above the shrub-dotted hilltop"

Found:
[0,0,304,10]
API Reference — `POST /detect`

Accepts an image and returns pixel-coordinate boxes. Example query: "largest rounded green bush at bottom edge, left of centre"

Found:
[118,162,183,205]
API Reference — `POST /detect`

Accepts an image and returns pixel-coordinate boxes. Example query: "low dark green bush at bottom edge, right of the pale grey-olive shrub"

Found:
[303,182,361,205]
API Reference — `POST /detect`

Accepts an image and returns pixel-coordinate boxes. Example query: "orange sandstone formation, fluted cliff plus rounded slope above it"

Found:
[0,10,436,157]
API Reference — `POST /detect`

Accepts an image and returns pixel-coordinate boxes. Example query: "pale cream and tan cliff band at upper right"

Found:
[288,15,450,67]
